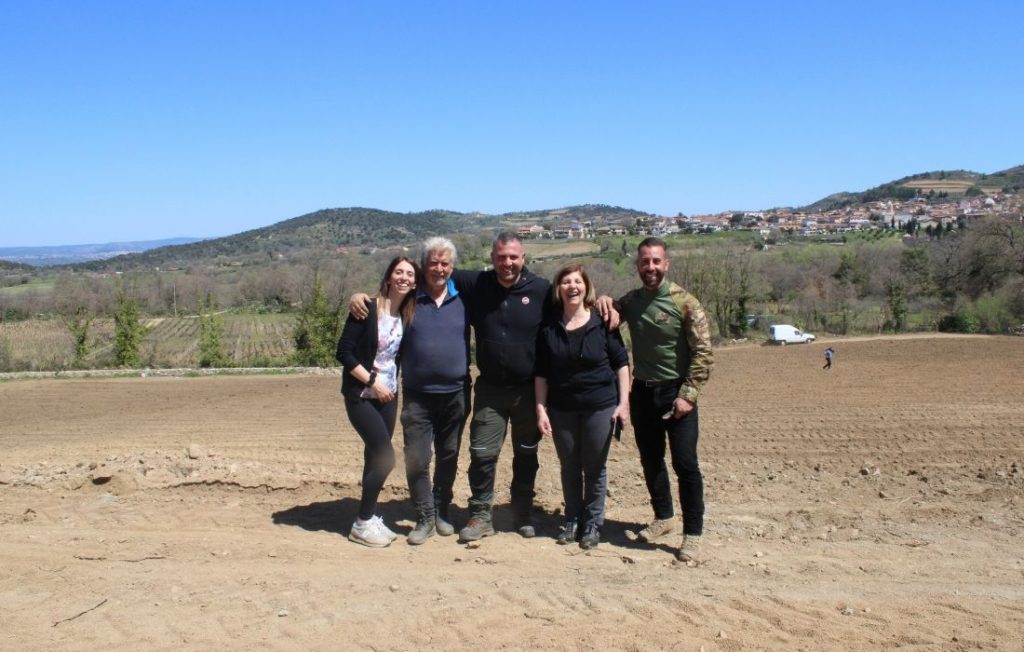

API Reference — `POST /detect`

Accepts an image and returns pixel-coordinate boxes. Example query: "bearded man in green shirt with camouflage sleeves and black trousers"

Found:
[599,237,713,563]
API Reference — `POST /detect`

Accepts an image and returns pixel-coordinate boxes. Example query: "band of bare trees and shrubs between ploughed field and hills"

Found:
[0,217,1024,367]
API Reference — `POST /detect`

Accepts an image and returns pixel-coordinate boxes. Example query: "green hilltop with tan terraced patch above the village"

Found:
[801,166,1024,212]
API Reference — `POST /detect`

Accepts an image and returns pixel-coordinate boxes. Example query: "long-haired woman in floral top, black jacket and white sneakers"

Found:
[335,256,419,548]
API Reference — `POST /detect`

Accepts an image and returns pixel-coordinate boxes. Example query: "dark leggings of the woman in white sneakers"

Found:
[345,396,398,520]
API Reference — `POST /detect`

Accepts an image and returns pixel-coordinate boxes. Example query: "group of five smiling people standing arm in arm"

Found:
[337,232,712,562]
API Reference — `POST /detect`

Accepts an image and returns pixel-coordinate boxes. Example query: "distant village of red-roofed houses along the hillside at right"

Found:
[517,192,1024,240]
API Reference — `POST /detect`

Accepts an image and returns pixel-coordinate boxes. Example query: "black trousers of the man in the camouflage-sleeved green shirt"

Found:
[630,382,705,535]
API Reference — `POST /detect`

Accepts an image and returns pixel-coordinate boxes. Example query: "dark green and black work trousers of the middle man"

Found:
[469,379,541,516]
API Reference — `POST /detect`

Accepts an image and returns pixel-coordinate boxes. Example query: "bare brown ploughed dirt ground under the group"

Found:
[0,337,1024,651]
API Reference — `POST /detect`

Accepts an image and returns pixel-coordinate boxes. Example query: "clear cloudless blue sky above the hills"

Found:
[0,0,1024,247]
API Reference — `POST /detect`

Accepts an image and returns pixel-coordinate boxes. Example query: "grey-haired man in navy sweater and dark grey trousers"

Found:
[349,237,470,546]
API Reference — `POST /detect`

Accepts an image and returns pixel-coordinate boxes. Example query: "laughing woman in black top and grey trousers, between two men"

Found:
[534,263,630,550]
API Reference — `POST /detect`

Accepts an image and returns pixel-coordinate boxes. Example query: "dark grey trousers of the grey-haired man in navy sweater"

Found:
[401,389,468,518]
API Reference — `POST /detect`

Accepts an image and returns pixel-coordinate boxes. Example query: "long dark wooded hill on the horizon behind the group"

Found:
[79,204,646,269]
